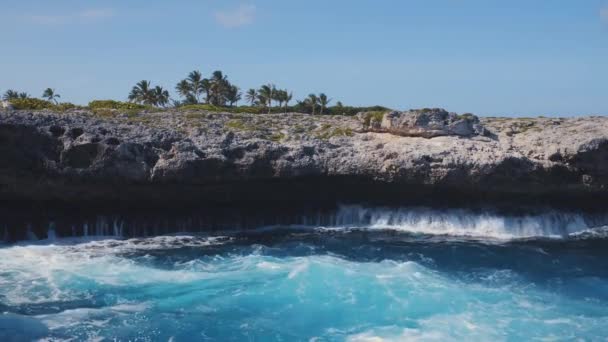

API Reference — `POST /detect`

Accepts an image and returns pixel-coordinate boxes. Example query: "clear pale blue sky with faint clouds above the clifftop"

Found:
[0,0,608,116]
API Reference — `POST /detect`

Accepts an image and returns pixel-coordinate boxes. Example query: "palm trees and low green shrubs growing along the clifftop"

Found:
[2,70,388,116]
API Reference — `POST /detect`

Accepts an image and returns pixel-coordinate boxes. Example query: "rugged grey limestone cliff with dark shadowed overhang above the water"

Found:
[0,110,608,206]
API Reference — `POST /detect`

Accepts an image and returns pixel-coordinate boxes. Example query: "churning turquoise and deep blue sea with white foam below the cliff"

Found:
[0,216,608,341]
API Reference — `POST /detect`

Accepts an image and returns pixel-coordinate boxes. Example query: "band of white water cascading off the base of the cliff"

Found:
[5,205,608,241]
